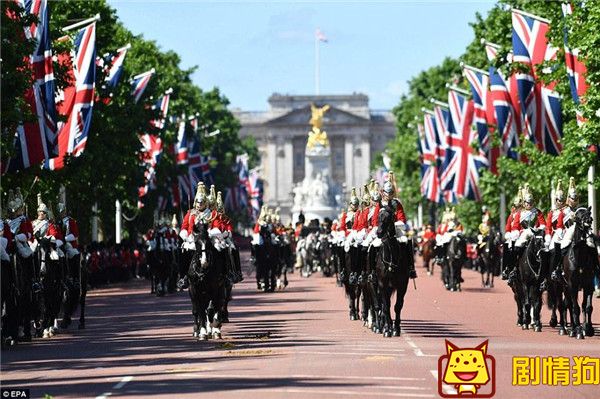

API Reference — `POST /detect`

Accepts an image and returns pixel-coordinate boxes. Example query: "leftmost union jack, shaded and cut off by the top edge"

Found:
[2,0,58,171]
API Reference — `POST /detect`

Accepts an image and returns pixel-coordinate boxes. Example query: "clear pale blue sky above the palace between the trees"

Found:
[109,0,494,110]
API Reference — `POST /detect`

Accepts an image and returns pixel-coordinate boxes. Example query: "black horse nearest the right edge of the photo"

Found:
[563,207,599,339]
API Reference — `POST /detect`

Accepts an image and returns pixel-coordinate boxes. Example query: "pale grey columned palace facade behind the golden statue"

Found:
[232,93,396,222]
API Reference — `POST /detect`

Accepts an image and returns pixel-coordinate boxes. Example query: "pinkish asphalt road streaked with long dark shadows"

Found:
[2,254,600,399]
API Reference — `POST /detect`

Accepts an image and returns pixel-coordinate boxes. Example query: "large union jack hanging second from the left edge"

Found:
[45,22,96,169]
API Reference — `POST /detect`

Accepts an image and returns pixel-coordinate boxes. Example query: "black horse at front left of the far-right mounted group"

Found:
[517,234,547,332]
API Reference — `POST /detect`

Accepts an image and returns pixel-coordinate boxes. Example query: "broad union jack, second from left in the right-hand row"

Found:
[440,90,488,201]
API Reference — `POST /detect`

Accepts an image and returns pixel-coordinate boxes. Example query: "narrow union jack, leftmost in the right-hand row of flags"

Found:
[419,113,442,202]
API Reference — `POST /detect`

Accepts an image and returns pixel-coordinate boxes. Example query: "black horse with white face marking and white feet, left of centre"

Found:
[188,223,227,340]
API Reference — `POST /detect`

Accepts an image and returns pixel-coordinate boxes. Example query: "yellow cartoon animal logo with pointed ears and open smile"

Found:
[438,340,495,398]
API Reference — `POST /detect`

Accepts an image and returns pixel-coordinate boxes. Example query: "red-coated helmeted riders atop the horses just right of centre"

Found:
[332,172,417,278]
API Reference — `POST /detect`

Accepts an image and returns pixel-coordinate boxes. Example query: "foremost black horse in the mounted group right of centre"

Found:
[375,207,413,337]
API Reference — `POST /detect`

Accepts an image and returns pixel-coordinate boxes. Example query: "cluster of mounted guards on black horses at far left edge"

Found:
[0,188,84,346]
